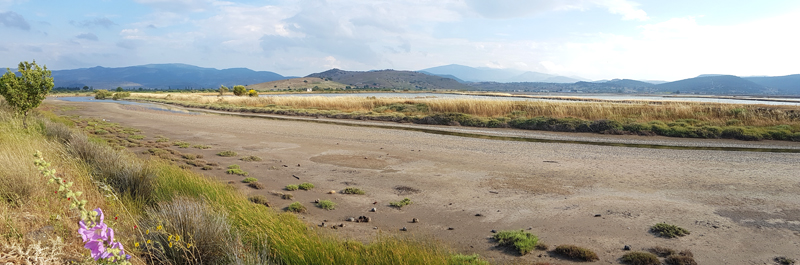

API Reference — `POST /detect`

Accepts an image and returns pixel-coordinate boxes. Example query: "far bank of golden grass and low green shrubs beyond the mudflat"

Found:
[132,94,800,141]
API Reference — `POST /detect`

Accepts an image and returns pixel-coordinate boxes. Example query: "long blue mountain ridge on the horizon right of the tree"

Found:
[52,64,286,89]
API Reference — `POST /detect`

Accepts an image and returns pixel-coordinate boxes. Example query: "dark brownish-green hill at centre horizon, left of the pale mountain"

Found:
[306,69,470,90]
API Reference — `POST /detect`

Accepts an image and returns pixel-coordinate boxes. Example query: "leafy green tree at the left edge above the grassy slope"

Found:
[0,61,55,128]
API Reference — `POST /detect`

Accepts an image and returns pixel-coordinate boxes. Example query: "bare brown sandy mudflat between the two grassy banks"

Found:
[47,100,800,264]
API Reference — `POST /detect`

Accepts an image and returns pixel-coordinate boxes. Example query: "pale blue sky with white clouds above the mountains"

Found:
[0,0,800,81]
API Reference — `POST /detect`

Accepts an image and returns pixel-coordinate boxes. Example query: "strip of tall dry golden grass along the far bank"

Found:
[135,94,800,126]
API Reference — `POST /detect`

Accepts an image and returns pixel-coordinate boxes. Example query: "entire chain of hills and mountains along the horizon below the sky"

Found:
[34,64,800,95]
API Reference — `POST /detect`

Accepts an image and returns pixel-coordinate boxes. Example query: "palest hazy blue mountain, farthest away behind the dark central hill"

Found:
[419,64,589,83]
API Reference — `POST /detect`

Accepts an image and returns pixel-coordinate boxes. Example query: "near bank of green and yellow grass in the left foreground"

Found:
[0,100,488,264]
